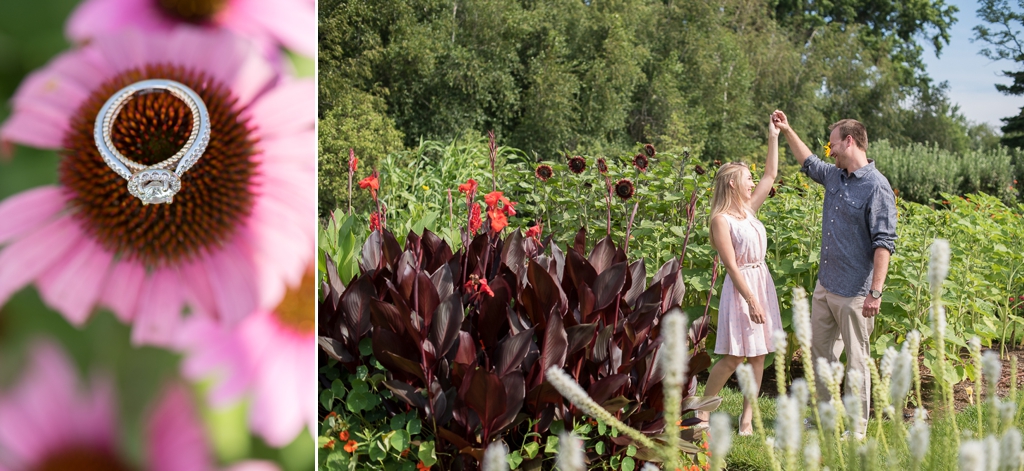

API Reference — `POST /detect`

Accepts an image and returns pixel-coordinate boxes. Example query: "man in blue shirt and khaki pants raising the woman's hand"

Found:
[772,111,896,436]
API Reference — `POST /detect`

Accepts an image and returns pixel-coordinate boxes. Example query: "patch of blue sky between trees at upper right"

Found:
[925,0,1024,130]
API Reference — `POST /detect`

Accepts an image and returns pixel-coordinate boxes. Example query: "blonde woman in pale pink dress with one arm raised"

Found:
[697,116,782,435]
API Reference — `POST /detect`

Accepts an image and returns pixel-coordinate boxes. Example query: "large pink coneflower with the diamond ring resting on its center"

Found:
[0,27,316,345]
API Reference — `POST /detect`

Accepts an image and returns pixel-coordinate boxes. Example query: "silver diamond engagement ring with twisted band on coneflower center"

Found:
[92,79,210,205]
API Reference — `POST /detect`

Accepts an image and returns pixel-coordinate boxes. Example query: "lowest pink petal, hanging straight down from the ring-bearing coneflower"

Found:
[131,268,184,347]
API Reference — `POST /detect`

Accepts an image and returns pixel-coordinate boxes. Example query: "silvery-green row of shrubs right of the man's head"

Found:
[869,140,1019,205]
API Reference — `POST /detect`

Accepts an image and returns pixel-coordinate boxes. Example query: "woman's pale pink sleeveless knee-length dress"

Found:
[715,213,782,356]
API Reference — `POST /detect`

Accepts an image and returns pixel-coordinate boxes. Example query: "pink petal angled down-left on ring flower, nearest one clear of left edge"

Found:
[37,238,114,327]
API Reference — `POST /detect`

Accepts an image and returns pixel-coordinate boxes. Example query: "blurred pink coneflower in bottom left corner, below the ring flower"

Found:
[0,343,278,471]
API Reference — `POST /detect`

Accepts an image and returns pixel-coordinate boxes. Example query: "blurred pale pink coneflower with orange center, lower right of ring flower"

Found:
[178,266,315,446]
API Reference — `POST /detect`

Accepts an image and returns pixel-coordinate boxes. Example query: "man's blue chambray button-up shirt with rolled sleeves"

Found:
[800,155,896,297]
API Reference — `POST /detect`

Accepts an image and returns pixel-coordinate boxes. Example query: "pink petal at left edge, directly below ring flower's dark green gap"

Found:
[0,186,68,245]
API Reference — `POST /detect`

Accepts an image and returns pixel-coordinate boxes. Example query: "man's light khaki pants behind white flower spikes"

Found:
[811,283,874,433]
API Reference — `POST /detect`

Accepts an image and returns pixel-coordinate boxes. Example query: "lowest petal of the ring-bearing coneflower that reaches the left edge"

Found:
[0,216,82,305]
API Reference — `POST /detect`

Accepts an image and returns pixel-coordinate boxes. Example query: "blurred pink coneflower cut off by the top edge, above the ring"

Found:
[66,0,316,56]
